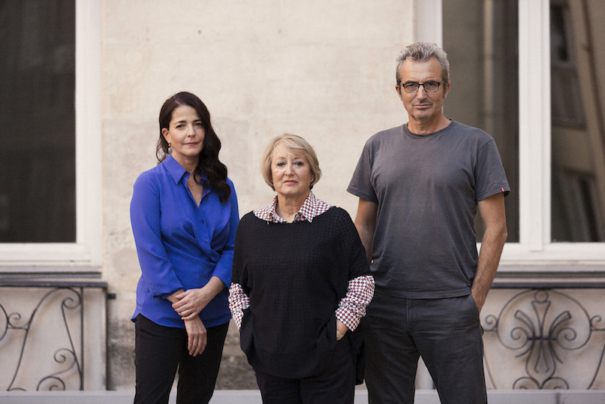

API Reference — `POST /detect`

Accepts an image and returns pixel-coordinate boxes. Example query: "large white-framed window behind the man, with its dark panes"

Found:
[414,0,605,273]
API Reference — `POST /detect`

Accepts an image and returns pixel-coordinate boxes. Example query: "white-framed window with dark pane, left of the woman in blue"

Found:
[0,0,102,274]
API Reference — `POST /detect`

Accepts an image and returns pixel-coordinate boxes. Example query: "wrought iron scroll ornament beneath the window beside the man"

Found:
[483,289,605,389]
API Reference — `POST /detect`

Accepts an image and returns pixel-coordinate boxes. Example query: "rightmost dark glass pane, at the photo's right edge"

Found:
[550,0,605,242]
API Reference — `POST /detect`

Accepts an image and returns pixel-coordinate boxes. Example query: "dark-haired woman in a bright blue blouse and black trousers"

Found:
[130,92,239,404]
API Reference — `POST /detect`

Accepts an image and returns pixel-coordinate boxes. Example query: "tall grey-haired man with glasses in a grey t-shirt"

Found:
[348,42,510,404]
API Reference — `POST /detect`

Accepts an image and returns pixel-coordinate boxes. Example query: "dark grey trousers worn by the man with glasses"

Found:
[365,293,487,404]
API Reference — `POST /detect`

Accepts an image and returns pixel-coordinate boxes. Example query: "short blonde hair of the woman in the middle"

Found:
[261,133,321,191]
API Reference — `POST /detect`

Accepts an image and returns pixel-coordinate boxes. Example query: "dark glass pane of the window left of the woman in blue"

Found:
[0,0,76,243]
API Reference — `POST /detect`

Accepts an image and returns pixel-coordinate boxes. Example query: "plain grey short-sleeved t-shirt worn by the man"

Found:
[347,121,510,299]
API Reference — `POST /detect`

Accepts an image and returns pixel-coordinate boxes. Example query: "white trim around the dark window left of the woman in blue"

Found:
[0,0,103,274]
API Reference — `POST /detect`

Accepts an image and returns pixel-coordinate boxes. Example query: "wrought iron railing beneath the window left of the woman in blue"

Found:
[0,280,107,391]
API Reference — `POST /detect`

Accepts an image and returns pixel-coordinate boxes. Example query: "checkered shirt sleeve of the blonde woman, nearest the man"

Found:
[336,275,374,331]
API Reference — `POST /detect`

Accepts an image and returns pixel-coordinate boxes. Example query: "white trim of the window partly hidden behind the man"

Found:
[414,0,605,275]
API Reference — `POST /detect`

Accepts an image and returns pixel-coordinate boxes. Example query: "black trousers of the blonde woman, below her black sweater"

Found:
[255,337,355,404]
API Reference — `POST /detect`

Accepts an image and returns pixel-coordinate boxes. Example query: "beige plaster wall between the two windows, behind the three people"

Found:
[102,0,413,390]
